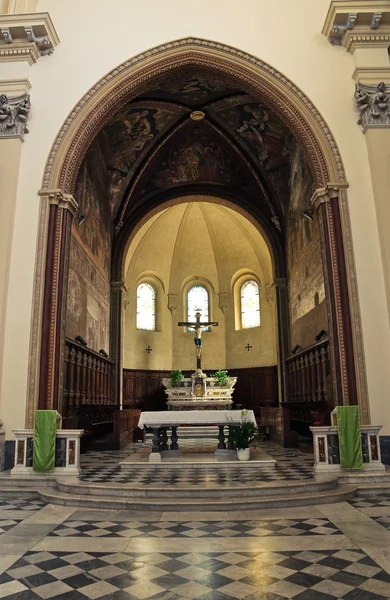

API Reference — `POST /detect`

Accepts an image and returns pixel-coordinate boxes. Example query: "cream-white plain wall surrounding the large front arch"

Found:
[1,0,390,435]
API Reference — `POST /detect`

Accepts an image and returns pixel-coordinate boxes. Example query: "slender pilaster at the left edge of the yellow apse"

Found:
[110,281,126,408]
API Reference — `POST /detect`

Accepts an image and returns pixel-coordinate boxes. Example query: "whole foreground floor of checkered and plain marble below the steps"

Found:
[0,498,390,600]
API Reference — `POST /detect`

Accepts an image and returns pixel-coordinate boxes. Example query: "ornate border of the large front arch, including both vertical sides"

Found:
[26,37,369,426]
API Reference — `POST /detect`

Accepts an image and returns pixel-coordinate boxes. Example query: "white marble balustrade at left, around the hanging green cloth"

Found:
[10,429,84,476]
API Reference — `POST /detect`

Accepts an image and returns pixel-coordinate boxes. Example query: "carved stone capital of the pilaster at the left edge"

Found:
[0,93,31,141]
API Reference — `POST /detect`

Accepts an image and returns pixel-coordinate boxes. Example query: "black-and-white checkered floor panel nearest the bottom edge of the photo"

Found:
[0,550,390,600]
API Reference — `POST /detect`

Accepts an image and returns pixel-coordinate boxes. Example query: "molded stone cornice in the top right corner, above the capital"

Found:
[322,0,390,53]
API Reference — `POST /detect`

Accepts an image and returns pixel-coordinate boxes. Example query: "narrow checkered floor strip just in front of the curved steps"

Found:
[50,518,341,539]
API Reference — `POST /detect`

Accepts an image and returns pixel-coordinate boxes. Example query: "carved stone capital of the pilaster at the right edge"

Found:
[355,81,390,131]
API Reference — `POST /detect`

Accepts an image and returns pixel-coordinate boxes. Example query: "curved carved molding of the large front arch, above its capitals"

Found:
[42,37,345,194]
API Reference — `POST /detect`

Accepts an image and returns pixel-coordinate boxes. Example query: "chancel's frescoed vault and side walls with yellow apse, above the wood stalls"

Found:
[66,67,329,390]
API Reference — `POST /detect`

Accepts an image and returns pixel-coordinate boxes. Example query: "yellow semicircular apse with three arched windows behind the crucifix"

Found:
[123,196,277,370]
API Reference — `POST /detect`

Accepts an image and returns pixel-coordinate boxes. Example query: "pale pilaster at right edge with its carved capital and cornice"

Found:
[322,0,390,354]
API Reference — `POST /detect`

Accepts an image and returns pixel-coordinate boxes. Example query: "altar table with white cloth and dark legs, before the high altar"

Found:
[138,410,256,462]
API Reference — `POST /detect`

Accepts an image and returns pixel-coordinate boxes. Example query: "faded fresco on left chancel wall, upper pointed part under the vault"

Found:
[72,140,112,280]
